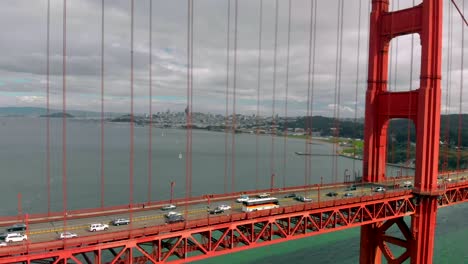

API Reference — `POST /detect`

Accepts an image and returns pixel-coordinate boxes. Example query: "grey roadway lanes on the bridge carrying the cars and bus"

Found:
[3,174,466,245]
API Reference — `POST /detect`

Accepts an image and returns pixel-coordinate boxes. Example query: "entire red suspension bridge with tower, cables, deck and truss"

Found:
[0,0,468,263]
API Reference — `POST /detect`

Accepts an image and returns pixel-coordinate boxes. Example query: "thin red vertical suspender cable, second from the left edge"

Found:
[62,0,67,231]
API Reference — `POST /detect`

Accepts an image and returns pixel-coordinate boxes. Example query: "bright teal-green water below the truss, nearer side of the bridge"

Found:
[196,204,468,264]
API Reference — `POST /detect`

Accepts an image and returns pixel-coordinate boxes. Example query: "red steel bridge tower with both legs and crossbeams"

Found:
[360,0,443,264]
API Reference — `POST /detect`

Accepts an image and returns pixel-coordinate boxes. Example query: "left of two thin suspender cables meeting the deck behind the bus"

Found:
[255,0,263,190]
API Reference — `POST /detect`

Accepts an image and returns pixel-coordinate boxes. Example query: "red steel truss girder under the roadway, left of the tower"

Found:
[0,192,415,263]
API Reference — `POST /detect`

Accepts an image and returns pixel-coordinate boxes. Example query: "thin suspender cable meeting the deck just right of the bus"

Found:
[283,0,291,189]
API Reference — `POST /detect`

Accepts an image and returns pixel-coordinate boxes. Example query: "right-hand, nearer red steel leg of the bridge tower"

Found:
[411,0,443,264]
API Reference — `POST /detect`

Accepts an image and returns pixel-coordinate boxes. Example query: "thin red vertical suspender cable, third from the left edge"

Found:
[101,0,104,208]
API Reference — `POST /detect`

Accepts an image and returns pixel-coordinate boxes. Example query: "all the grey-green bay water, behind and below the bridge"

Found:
[0,118,468,264]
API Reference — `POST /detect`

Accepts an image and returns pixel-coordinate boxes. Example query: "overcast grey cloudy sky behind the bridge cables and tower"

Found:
[0,0,468,117]
